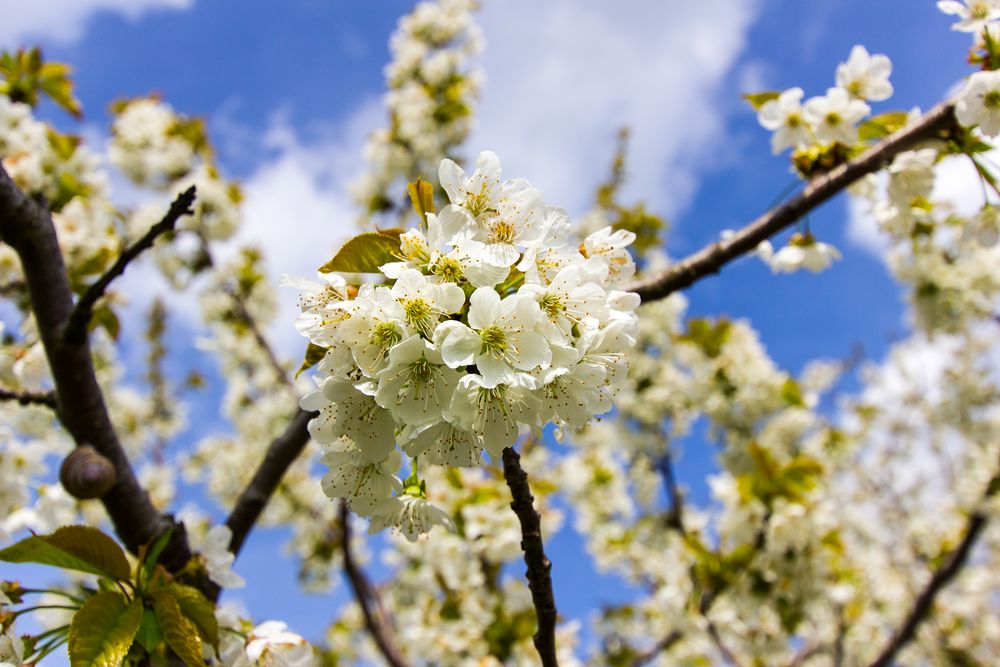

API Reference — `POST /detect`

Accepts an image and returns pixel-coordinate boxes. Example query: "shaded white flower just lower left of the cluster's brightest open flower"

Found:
[375,334,460,426]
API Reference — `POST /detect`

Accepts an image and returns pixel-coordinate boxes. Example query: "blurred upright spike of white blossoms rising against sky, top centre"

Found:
[352,0,483,224]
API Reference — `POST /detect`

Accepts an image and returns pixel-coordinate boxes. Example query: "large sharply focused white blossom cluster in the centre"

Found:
[296,152,639,538]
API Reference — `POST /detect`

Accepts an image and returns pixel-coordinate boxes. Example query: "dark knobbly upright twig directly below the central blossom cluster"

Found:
[503,447,559,667]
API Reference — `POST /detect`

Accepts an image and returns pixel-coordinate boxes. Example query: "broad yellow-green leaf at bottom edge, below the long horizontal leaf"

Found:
[69,591,142,667]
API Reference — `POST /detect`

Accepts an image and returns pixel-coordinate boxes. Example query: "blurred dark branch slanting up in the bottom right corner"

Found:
[868,464,1000,667]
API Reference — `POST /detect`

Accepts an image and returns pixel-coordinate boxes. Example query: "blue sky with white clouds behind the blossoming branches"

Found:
[0,0,969,656]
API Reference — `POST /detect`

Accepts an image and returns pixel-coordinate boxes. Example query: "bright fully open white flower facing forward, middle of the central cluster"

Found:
[434,287,552,387]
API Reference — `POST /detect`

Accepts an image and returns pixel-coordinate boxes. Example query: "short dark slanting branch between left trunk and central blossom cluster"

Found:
[226,410,317,554]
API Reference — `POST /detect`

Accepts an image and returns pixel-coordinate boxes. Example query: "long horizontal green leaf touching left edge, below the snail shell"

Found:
[0,526,131,581]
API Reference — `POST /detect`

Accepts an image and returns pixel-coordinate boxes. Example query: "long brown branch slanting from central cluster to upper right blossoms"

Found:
[624,102,955,301]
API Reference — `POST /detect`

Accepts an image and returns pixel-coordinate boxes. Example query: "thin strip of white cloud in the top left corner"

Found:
[0,0,194,48]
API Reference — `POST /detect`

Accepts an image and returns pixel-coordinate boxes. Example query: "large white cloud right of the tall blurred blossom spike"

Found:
[468,0,757,215]
